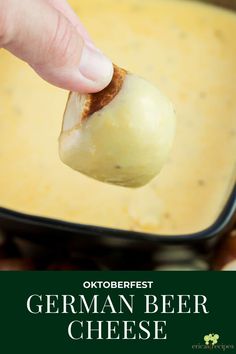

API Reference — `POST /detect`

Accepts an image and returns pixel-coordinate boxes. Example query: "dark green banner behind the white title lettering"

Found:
[0,272,236,354]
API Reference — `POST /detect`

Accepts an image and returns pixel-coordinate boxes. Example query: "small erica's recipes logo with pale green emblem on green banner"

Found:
[192,333,235,352]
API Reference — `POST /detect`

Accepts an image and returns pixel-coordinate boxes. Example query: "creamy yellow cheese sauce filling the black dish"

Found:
[0,0,236,235]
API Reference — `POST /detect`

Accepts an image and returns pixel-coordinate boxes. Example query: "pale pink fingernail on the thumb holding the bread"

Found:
[79,42,113,88]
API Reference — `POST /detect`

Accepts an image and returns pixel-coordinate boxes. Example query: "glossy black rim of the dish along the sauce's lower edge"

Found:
[0,184,236,243]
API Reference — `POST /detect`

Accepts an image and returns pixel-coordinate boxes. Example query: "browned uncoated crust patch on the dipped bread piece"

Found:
[81,65,127,121]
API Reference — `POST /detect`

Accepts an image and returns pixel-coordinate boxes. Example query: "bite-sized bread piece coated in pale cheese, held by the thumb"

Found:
[59,67,175,187]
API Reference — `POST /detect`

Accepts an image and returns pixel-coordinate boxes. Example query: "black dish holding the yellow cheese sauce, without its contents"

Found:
[0,0,236,254]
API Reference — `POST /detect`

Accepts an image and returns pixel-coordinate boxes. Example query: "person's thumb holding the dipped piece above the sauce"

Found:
[0,0,113,93]
